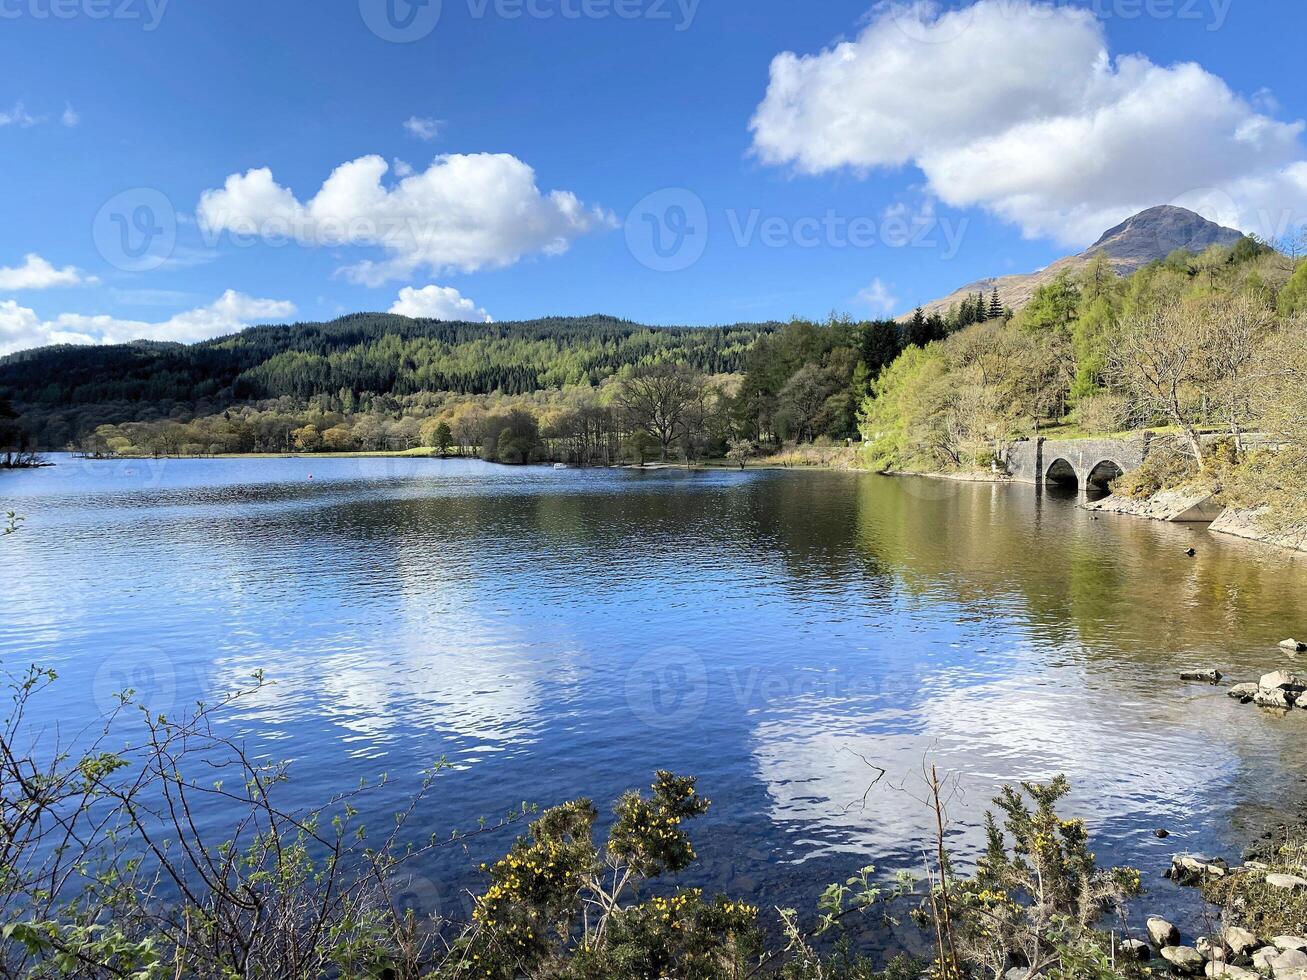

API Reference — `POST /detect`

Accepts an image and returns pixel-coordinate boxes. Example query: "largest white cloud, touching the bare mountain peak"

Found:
[752,0,1307,243]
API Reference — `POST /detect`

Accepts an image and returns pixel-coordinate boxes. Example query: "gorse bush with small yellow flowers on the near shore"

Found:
[439,772,761,980]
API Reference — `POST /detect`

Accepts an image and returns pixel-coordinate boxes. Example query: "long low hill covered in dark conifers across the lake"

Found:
[0,314,774,448]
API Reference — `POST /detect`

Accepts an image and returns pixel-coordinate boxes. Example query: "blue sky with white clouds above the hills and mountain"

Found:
[0,0,1307,351]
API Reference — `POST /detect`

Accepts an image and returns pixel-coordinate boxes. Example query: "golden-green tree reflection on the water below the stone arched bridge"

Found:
[857,478,1307,670]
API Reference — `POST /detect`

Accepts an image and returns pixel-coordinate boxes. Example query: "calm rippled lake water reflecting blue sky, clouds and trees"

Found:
[0,457,1307,946]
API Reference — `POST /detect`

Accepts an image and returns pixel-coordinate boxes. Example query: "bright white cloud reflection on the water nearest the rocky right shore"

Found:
[753,653,1239,860]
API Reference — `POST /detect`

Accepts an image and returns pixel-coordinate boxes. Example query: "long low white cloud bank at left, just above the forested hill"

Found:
[0,289,295,354]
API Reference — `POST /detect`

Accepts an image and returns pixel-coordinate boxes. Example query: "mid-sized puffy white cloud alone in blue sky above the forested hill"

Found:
[199,153,617,285]
